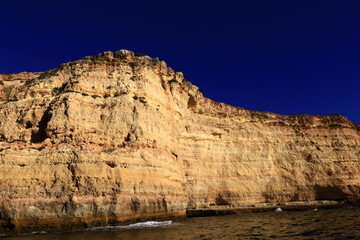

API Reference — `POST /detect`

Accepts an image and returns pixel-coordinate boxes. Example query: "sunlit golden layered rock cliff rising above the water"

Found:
[0,50,360,232]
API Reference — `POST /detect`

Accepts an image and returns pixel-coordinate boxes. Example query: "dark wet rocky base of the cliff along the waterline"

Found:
[0,201,354,236]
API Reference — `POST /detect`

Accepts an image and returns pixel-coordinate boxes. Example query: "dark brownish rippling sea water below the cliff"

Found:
[0,207,360,240]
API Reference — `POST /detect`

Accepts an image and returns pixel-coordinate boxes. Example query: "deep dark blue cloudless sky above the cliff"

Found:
[0,0,360,123]
